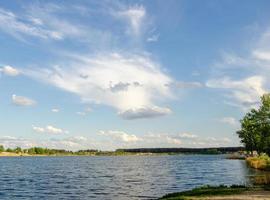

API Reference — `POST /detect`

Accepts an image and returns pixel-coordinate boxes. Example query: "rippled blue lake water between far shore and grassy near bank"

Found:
[0,155,262,200]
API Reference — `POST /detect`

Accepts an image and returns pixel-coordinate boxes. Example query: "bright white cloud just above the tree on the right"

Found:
[206,76,266,109]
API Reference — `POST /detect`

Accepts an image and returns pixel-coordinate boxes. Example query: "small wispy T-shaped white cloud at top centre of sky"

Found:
[117,5,146,35]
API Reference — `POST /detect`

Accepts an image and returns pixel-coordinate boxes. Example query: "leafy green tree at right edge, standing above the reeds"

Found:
[237,94,270,155]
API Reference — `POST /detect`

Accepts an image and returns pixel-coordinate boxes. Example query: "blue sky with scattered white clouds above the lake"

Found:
[0,0,270,150]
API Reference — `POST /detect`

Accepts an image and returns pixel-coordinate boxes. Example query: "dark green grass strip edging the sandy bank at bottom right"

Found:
[160,185,249,200]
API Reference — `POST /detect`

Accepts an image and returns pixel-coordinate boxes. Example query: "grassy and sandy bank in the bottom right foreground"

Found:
[160,185,270,200]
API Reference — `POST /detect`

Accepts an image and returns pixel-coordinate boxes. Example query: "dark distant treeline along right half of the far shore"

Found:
[116,147,244,154]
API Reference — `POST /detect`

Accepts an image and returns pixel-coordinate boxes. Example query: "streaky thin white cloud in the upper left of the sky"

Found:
[0,3,111,43]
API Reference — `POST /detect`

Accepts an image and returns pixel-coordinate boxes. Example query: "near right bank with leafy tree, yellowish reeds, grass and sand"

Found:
[160,94,270,200]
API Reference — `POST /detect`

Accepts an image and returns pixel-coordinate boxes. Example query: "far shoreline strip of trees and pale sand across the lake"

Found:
[0,145,243,156]
